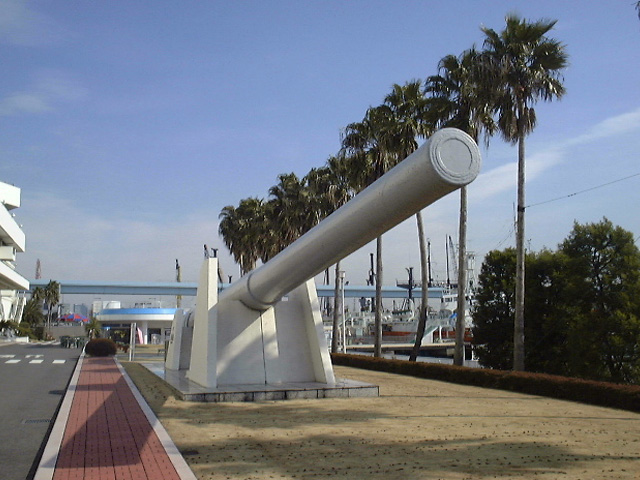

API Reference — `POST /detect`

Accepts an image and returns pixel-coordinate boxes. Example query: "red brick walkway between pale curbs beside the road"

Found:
[53,357,180,480]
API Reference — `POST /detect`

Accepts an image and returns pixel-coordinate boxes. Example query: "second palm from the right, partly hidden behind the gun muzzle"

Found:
[424,48,495,365]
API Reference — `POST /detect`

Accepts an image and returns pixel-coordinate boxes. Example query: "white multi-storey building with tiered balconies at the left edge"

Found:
[0,182,29,322]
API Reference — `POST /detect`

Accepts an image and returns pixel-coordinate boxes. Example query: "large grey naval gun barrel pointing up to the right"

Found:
[225,128,481,310]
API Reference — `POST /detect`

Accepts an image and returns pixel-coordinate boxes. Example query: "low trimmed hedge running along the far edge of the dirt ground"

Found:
[331,353,640,412]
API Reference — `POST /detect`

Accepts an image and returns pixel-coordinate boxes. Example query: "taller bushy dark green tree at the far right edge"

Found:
[560,218,640,383]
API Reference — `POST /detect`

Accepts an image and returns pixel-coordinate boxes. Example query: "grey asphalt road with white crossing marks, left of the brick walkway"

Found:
[0,344,80,480]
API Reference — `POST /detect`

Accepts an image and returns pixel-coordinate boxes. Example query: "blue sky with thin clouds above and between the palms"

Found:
[0,0,640,296]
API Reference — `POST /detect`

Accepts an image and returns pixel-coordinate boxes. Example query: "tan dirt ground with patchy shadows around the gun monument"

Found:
[123,363,640,480]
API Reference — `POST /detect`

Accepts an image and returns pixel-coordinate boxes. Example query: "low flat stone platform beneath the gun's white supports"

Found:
[141,362,380,402]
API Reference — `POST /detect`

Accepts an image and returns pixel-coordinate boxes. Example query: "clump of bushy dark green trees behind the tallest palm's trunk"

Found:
[473,218,640,383]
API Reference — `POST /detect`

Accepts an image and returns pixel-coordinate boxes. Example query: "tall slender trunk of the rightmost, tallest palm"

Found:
[513,114,525,371]
